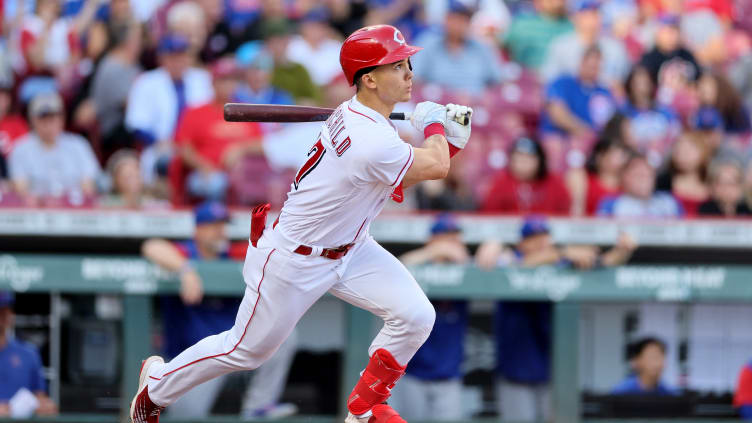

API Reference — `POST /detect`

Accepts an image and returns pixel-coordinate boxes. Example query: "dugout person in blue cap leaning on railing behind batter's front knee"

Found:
[392,213,470,421]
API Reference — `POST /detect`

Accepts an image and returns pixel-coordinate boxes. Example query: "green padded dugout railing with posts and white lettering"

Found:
[0,254,752,423]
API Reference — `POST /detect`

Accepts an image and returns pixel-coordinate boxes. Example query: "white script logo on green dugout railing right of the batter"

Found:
[507,267,582,301]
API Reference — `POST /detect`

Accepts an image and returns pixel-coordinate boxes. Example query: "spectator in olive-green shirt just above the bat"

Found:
[260,19,322,104]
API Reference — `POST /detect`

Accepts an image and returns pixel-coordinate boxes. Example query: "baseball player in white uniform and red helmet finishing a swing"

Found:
[130,25,472,423]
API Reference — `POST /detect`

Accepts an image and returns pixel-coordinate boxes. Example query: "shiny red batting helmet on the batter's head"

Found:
[339,25,423,85]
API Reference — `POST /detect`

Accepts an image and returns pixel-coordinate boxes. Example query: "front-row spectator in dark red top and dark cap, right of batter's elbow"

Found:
[482,137,571,215]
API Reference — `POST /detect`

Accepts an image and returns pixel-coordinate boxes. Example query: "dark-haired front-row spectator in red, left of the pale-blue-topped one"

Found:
[566,138,629,216]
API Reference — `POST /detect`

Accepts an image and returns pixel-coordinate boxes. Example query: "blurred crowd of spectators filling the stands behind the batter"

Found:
[0,0,752,217]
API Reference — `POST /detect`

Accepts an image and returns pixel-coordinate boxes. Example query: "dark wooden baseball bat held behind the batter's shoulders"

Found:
[220,103,469,125]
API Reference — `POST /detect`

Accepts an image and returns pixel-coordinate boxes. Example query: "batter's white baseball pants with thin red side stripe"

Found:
[149,227,436,406]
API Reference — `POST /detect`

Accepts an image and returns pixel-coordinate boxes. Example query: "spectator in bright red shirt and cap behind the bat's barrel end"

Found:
[175,58,263,200]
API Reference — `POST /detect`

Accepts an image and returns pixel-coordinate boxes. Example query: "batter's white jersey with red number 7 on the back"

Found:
[276,97,415,248]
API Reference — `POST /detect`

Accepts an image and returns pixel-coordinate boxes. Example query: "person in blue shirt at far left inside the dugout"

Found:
[0,291,57,418]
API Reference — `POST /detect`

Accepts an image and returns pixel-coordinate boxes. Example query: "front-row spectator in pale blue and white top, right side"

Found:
[597,153,684,218]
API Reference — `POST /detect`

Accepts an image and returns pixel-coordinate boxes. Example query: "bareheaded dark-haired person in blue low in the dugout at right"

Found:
[611,337,677,395]
